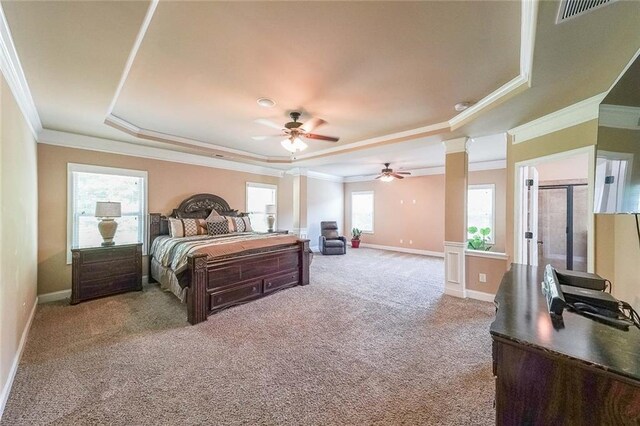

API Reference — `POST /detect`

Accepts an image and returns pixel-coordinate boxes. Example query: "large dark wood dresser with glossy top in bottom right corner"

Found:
[491,264,640,426]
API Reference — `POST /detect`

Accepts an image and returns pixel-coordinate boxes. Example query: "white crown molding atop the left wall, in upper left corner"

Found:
[0,5,42,138]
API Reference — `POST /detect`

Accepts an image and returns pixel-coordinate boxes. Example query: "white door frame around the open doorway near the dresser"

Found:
[513,145,596,273]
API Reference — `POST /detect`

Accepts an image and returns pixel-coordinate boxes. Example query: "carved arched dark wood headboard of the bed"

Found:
[149,194,243,248]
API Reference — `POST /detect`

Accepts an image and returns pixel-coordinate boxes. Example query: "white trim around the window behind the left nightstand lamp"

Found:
[67,163,149,265]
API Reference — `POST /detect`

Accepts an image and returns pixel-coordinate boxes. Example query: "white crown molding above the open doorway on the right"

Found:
[507,92,606,144]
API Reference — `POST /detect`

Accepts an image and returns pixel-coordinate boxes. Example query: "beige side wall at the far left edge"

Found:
[0,78,38,415]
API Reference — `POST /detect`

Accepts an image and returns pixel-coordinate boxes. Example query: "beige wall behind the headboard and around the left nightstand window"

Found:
[38,144,279,294]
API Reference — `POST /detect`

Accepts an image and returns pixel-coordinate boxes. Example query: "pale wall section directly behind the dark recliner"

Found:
[307,178,342,247]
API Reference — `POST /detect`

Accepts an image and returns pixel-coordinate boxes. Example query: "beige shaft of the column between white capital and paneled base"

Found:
[444,151,468,242]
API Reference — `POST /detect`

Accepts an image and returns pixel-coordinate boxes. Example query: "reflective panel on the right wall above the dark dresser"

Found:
[593,54,640,213]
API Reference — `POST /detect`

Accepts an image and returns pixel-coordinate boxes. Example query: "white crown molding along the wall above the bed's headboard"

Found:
[37,129,284,177]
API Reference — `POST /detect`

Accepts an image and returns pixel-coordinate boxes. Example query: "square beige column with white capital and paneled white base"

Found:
[443,137,469,298]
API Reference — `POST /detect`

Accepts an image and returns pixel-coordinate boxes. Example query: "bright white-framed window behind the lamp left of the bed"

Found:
[67,163,147,263]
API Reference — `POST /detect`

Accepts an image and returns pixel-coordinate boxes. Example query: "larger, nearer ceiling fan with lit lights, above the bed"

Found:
[252,111,340,153]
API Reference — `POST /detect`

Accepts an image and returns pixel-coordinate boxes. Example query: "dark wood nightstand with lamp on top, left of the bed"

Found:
[71,243,142,305]
